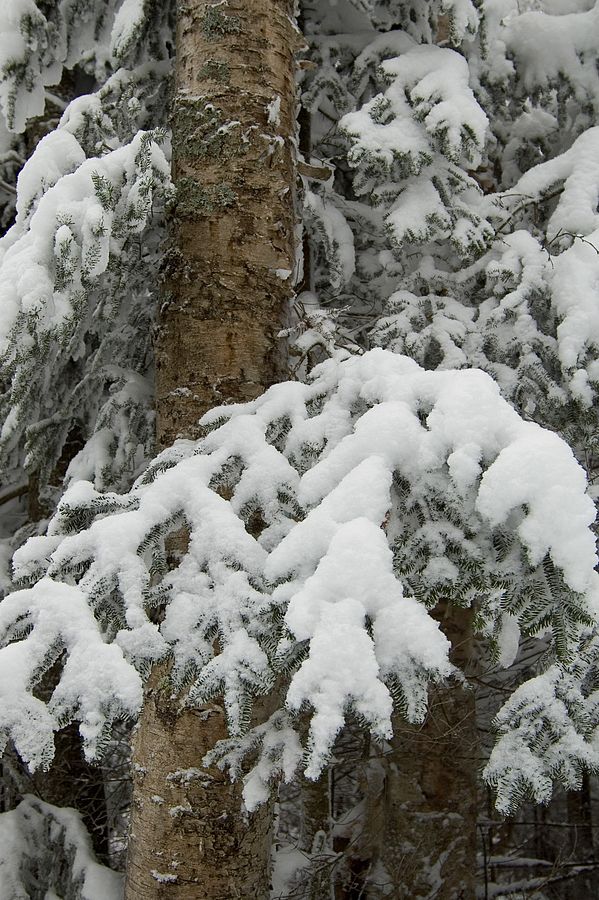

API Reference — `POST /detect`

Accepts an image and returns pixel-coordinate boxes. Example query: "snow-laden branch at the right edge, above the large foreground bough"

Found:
[480,127,599,407]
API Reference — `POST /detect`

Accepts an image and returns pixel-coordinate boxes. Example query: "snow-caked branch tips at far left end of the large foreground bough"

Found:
[0,578,142,769]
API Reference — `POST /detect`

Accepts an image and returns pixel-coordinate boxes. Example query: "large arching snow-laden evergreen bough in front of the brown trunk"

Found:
[0,350,597,806]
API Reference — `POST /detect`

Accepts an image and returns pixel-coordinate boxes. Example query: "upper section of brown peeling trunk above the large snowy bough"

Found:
[156,0,300,445]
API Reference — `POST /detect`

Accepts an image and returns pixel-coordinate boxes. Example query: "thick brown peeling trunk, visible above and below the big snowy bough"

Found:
[125,0,299,900]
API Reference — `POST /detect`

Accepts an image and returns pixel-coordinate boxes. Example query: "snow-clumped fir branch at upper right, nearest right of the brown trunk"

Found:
[339,31,492,259]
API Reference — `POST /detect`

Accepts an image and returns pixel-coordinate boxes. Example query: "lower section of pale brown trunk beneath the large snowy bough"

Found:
[125,666,272,900]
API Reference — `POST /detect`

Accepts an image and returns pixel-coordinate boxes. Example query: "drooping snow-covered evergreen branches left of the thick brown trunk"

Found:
[0,110,170,502]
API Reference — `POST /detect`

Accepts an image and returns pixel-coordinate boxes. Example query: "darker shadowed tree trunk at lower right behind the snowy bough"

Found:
[349,607,478,900]
